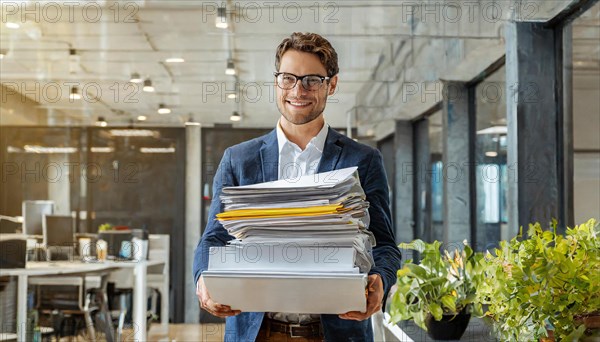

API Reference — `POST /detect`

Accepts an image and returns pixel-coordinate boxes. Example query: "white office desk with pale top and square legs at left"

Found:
[0,260,164,341]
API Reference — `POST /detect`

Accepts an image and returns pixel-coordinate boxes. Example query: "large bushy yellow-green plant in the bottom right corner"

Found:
[478,219,600,341]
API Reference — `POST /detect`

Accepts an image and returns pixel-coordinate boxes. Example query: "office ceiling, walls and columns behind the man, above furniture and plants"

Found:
[0,0,600,336]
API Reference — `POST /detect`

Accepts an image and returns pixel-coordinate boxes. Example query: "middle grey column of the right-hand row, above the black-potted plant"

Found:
[442,81,477,246]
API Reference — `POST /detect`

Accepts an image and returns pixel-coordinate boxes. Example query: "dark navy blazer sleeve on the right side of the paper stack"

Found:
[363,150,402,310]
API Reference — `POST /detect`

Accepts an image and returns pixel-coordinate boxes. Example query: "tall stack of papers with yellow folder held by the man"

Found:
[202,167,375,314]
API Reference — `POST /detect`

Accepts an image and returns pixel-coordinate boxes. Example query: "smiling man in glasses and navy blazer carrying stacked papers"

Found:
[194,33,400,341]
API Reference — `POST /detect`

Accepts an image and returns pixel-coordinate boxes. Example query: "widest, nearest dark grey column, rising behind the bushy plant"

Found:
[506,22,569,234]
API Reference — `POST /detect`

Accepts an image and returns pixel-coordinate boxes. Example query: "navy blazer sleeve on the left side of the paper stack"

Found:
[193,148,238,284]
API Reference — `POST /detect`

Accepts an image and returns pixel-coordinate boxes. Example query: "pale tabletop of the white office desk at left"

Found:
[0,260,164,276]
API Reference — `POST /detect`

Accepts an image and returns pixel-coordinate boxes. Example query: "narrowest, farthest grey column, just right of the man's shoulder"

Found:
[394,120,416,243]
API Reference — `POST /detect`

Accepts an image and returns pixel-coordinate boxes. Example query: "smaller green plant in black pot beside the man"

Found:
[390,240,483,340]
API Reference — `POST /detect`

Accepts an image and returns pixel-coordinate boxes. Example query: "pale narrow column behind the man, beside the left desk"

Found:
[184,126,202,323]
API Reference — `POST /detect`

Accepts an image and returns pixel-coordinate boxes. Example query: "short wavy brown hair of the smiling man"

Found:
[275,32,340,77]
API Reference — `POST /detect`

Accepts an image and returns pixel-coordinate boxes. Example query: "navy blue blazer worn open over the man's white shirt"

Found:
[193,128,401,341]
